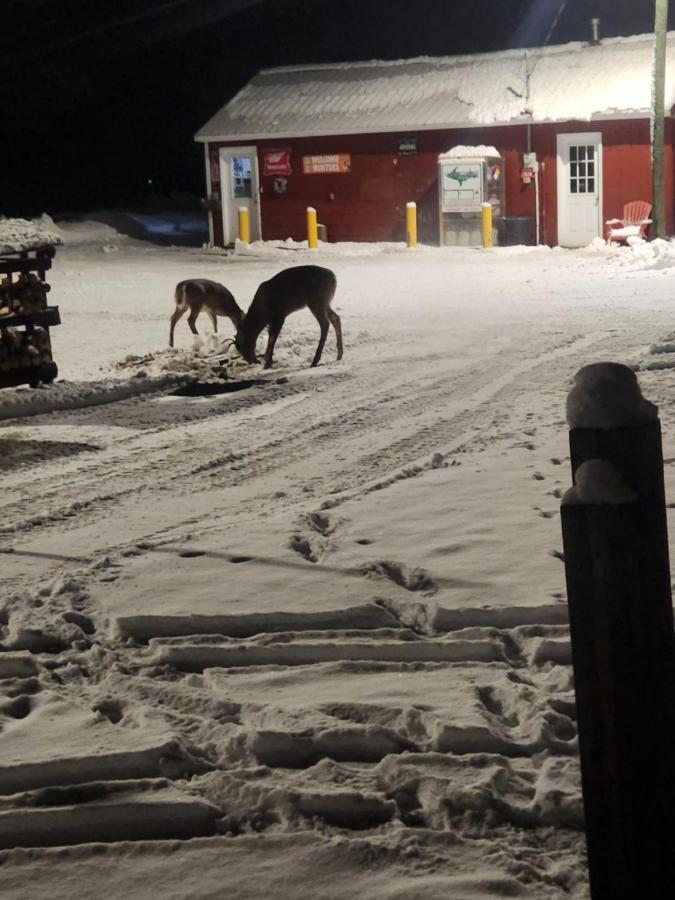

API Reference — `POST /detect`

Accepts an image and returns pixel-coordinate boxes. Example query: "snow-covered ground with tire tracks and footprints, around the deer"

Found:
[0,224,675,900]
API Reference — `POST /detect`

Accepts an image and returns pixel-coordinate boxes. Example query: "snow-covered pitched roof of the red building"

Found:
[195,32,675,141]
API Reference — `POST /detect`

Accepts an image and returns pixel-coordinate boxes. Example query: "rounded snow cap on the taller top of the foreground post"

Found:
[567,362,658,428]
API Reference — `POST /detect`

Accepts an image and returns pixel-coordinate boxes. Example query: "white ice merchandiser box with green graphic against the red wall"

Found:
[438,146,504,247]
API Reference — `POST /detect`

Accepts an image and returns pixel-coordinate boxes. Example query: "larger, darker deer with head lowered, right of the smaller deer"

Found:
[235,266,342,369]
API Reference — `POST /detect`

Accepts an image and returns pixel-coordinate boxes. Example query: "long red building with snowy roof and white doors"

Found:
[196,32,675,247]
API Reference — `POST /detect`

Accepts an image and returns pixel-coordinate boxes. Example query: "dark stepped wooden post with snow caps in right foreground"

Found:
[561,363,675,900]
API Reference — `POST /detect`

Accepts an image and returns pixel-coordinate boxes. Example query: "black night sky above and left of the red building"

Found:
[0,0,664,215]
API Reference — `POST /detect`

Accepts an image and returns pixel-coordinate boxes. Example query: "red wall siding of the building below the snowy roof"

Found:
[211,119,675,250]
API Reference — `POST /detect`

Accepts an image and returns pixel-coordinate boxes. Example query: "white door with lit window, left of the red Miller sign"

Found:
[220,147,260,244]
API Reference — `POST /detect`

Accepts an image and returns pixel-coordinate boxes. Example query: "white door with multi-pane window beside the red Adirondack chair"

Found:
[558,131,602,247]
